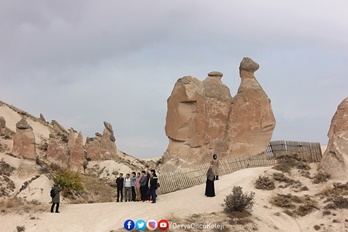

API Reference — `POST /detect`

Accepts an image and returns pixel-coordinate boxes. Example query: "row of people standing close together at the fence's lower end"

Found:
[116,169,159,203]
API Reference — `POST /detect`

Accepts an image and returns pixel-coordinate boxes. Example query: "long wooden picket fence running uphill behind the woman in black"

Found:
[157,141,322,194]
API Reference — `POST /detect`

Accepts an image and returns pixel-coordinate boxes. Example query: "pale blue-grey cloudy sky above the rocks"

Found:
[0,0,348,158]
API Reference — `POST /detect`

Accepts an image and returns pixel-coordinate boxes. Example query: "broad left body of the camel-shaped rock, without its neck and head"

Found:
[163,71,232,164]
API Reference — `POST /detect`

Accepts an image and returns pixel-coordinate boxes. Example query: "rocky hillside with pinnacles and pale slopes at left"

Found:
[0,102,155,202]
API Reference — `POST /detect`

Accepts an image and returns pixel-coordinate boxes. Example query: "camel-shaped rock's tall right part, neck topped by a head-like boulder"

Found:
[228,58,275,156]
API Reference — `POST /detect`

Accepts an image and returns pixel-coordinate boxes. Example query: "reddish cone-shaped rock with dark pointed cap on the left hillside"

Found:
[12,118,36,160]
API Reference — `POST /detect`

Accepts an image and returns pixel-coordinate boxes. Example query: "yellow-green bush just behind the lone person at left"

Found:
[53,169,83,192]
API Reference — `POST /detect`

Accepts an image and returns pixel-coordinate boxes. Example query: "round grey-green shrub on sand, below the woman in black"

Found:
[224,186,255,212]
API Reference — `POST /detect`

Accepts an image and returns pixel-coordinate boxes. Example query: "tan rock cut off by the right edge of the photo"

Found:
[321,97,348,181]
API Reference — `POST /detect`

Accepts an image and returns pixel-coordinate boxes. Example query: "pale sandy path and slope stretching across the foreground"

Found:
[0,167,348,232]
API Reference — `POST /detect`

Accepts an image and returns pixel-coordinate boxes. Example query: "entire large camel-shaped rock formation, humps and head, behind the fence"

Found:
[163,58,275,164]
